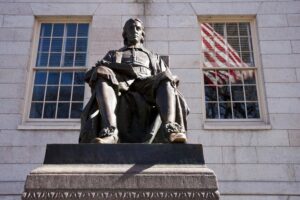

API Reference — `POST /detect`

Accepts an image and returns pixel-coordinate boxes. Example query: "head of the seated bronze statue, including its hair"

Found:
[122,18,145,46]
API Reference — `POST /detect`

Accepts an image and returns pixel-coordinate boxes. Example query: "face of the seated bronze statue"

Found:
[125,21,143,45]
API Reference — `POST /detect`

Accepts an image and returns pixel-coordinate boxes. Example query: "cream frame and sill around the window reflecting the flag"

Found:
[198,16,271,130]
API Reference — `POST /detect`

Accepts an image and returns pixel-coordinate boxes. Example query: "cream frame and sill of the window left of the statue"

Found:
[18,16,92,130]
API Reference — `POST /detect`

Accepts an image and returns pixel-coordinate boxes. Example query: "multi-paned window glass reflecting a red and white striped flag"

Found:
[200,21,261,120]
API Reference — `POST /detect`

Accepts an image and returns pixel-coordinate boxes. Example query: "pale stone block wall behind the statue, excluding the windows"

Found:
[0,0,300,200]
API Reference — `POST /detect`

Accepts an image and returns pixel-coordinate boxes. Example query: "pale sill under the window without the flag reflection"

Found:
[17,122,80,131]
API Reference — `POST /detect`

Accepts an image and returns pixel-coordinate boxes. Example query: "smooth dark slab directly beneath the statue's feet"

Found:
[44,144,205,165]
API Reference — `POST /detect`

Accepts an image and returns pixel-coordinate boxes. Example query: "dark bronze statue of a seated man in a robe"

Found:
[79,19,189,143]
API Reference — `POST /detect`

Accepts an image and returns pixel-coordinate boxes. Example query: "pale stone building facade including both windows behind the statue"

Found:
[0,0,300,200]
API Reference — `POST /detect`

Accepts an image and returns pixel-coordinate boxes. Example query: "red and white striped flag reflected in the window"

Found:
[201,23,254,85]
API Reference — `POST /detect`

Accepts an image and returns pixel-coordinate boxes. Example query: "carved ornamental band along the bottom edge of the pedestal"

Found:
[22,189,220,200]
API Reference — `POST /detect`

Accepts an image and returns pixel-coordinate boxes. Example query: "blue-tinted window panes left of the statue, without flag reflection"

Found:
[29,23,89,119]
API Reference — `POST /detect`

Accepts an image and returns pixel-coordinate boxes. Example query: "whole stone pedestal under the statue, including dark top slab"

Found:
[22,144,219,200]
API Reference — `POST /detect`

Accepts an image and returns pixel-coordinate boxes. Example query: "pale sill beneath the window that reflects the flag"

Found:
[203,122,272,130]
